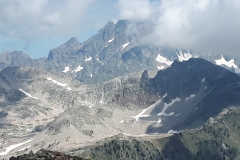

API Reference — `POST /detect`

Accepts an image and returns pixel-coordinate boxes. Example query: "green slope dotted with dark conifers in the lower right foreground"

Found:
[76,108,240,160]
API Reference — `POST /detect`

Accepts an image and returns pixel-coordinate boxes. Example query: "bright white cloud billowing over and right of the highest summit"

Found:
[119,0,240,56]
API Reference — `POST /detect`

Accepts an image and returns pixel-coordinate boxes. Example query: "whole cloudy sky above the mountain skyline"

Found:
[0,0,240,58]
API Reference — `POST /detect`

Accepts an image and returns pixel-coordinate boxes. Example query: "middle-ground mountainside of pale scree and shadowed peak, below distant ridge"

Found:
[0,58,240,157]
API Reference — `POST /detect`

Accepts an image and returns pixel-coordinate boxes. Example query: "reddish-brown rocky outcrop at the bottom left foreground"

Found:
[10,149,86,160]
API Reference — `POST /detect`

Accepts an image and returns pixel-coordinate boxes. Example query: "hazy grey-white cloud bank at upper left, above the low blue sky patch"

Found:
[0,0,117,41]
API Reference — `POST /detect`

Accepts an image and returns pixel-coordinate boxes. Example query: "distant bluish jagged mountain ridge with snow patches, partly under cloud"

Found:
[0,20,240,84]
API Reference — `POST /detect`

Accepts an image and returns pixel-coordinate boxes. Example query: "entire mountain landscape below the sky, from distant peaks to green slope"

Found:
[0,20,240,160]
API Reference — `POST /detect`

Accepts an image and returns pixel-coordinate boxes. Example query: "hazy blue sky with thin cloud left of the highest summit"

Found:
[0,0,118,58]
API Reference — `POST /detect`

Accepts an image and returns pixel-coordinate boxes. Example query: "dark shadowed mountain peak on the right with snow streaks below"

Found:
[141,59,240,132]
